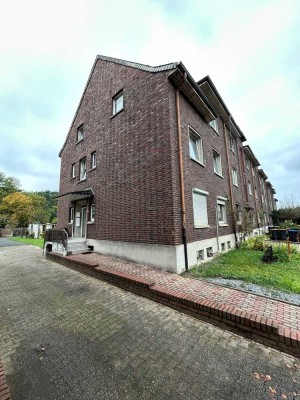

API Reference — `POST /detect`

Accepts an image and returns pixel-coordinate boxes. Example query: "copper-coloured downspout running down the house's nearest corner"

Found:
[175,72,189,271]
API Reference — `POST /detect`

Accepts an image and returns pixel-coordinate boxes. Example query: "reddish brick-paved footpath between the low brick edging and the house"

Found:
[69,253,300,331]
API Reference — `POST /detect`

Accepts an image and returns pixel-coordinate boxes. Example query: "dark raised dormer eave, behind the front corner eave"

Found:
[197,75,247,142]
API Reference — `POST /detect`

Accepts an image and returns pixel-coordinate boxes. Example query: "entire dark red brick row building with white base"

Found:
[57,56,275,273]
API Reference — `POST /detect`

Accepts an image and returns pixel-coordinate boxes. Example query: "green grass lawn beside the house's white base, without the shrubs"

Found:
[185,249,300,293]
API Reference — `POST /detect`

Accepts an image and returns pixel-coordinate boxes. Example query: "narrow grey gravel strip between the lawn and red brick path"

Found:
[203,278,300,306]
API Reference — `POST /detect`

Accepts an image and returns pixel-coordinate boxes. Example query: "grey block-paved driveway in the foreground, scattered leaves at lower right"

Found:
[0,246,300,400]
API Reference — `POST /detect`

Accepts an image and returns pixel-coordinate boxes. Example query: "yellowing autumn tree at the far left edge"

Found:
[0,192,34,227]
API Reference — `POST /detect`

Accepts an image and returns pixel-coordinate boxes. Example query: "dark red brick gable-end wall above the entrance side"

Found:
[58,60,180,244]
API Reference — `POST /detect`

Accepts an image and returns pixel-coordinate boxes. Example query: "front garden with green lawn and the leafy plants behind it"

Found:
[185,236,300,294]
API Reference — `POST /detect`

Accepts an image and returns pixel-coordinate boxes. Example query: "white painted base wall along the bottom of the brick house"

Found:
[87,234,235,274]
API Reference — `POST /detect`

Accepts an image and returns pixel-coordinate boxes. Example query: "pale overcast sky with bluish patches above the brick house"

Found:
[0,0,300,203]
